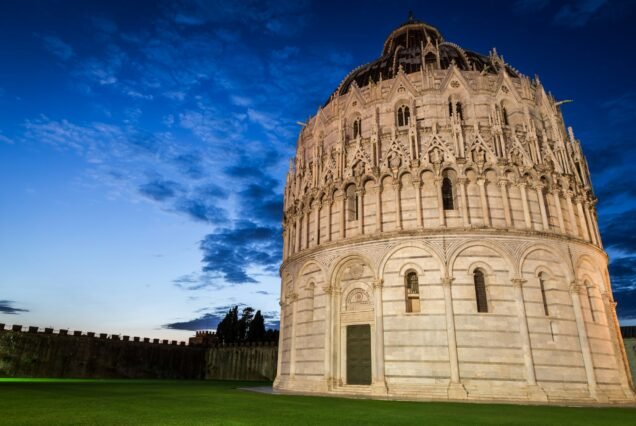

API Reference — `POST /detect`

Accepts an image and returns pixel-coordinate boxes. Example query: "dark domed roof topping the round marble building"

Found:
[332,15,517,100]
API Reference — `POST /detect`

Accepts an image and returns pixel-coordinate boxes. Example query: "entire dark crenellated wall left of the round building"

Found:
[0,324,278,381]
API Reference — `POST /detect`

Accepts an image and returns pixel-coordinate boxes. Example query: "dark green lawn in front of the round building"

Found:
[0,379,636,426]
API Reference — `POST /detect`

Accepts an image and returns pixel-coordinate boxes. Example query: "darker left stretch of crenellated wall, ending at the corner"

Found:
[0,326,205,379]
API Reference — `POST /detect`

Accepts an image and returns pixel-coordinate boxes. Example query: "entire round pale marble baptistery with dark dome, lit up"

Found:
[274,18,634,403]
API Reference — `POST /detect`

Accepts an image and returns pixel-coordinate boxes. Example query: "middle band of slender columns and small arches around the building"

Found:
[283,165,601,259]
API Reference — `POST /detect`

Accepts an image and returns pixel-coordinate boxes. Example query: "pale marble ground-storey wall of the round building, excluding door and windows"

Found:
[276,235,633,402]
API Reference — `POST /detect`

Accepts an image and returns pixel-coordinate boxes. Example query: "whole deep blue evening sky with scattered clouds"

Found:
[0,0,636,338]
